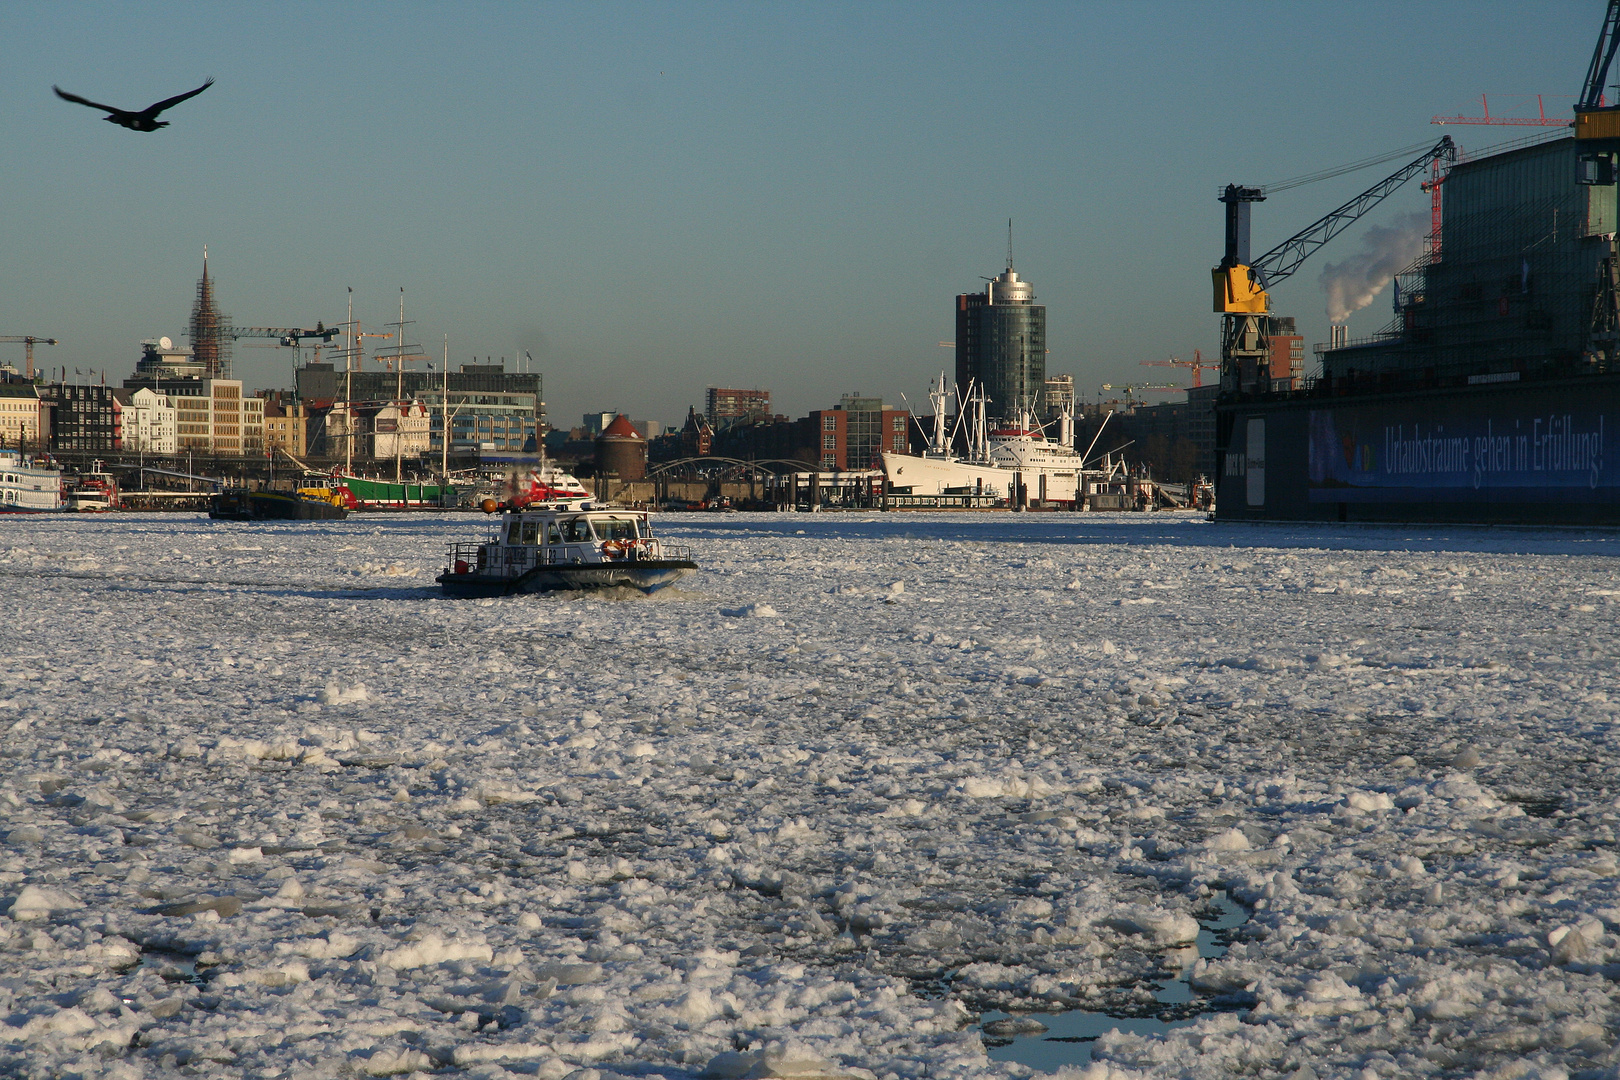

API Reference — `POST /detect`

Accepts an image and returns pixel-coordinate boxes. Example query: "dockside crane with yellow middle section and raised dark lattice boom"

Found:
[1210,132,1464,393]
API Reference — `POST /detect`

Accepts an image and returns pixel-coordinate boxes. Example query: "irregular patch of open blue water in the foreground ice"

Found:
[978,892,1249,1072]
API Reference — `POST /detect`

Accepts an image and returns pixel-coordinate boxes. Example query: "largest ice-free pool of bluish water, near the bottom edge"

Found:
[980,892,1249,1072]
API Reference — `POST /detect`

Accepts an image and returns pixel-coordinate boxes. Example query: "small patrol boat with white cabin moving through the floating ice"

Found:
[437,499,698,597]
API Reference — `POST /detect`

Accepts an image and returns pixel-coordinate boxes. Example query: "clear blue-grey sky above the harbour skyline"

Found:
[0,0,1602,423]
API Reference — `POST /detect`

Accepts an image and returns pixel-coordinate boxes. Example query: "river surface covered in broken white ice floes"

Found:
[0,513,1620,1080]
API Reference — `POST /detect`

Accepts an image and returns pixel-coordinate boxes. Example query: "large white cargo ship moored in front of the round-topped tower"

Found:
[883,372,1128,505]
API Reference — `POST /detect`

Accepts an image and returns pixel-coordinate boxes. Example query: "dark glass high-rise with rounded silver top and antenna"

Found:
[956,251,1047,418]
